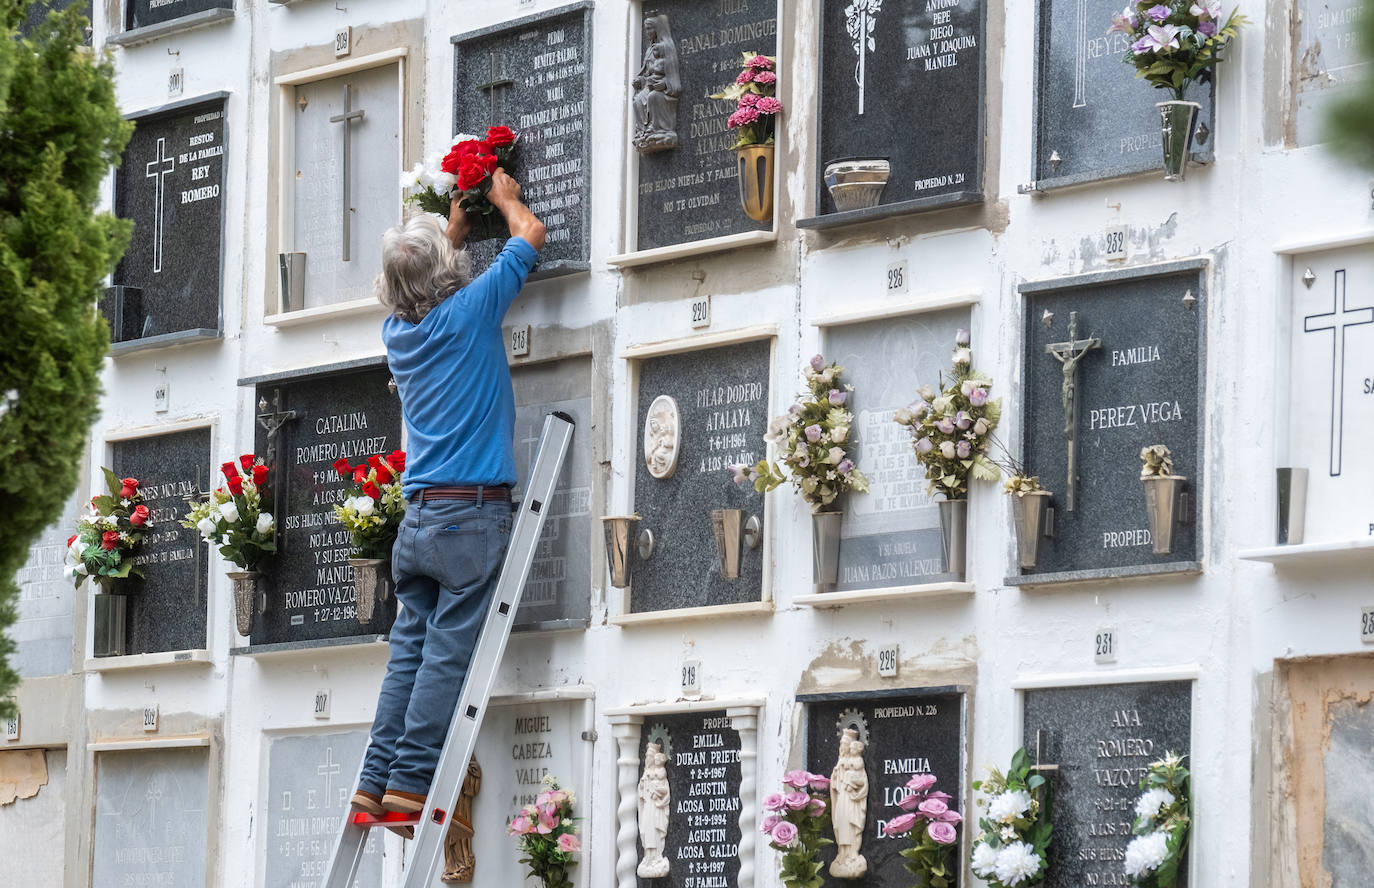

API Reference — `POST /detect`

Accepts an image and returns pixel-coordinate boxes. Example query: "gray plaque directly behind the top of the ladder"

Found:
[511,357,588,630]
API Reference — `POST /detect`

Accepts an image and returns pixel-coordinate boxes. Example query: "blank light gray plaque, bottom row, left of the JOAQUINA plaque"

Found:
[91,748,210,888]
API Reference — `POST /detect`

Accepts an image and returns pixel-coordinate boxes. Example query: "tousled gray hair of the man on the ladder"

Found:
[376,213,473,324]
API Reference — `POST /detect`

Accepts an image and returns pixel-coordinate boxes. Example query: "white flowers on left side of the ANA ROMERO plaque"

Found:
[970,749,1052,888]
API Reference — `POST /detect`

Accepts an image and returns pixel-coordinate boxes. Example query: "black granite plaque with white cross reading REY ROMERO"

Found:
[114,96,227,342]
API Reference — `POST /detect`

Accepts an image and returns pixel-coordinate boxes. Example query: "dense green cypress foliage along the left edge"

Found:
[0,0,133,712]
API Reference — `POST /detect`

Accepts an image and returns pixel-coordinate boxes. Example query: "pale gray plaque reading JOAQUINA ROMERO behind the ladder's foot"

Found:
[262,731,382,888]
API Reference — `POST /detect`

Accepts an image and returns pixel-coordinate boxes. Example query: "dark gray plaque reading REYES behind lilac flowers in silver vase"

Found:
[1035,0,1213,187]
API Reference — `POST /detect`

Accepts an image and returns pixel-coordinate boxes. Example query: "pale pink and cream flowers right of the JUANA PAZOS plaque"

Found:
[893,330,1002,500]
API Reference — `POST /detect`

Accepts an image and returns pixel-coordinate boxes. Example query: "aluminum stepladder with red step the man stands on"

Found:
[320,412,573,888]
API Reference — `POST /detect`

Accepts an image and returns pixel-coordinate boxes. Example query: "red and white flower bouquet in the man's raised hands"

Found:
[401,126,519,241]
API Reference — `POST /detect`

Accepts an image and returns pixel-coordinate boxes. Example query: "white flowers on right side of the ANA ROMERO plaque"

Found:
[1125,752,1193,888]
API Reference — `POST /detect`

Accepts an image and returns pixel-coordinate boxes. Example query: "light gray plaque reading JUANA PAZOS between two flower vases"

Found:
[826,308,967,591]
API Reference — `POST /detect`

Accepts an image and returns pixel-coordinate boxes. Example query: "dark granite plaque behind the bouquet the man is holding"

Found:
[453,3,592,275]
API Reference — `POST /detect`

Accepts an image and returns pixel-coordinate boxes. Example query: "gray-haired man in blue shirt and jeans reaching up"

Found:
[353,169,544,837]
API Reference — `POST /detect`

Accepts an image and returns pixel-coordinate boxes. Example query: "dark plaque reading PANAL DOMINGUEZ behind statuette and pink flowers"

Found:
[627,0,787,250]
